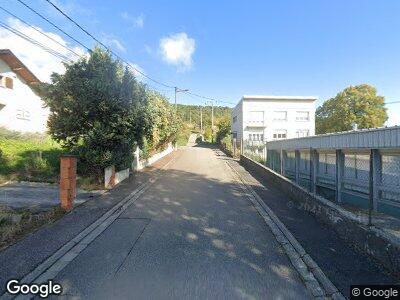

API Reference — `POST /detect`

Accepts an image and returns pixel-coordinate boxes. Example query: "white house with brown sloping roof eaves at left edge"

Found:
[0,49,49,133]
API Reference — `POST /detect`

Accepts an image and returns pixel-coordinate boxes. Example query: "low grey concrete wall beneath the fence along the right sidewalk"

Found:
[241,155,400,274]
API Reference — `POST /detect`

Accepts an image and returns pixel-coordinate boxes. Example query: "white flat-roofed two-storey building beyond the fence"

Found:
[232,96,317,141]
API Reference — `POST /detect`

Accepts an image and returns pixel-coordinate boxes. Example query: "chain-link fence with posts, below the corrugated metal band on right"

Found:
[243,141,400,217]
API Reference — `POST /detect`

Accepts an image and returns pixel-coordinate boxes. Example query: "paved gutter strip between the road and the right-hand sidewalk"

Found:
[225,161,345,299]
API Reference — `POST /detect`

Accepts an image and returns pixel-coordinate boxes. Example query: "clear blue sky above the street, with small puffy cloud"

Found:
[0,0,400,124]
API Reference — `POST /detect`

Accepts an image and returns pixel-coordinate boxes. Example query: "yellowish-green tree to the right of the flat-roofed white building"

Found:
[316,84,388,134]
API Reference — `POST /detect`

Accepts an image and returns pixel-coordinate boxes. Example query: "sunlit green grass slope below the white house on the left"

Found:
[0,129,63,182]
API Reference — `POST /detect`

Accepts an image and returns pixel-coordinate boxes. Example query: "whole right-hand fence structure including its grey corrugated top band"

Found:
[242,126,400,218]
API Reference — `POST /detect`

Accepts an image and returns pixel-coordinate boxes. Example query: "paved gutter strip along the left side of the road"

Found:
[0,152,176,300]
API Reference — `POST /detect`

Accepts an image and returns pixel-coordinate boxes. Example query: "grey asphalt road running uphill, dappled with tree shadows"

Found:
[54,147,311,299]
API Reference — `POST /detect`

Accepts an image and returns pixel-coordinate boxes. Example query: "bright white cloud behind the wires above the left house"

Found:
[0,18,86,82]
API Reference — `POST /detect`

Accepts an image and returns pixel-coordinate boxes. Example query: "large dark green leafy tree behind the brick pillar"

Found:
[41,48,147,180]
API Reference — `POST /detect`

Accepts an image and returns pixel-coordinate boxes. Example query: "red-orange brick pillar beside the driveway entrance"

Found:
[60,155,77,211]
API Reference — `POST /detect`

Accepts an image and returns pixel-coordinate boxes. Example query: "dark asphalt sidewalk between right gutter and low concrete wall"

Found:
[231,161,400,297]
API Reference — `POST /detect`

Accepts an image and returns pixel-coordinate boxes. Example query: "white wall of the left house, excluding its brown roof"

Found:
[0,60,49,133]
